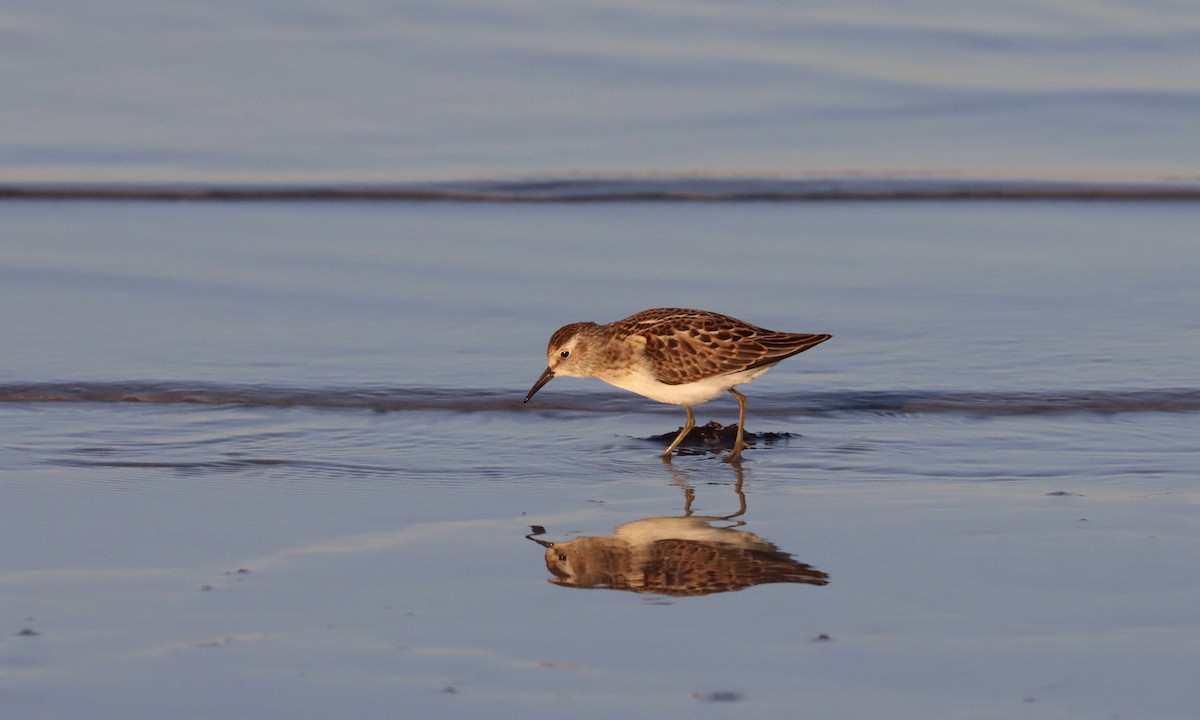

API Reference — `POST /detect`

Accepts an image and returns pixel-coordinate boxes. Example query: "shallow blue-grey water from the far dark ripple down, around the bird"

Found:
[0,202,1200,719]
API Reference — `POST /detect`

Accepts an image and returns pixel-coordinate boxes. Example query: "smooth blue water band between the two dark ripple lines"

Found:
[0,203,1200,400]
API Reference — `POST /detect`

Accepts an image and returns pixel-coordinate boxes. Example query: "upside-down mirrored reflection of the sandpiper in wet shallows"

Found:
[527,476,829,596]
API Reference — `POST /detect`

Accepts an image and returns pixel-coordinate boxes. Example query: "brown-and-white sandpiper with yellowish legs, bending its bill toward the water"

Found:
[524,307,833,462]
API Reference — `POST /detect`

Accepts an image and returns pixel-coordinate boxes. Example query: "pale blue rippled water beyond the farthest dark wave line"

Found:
[7,0,1200,182]
